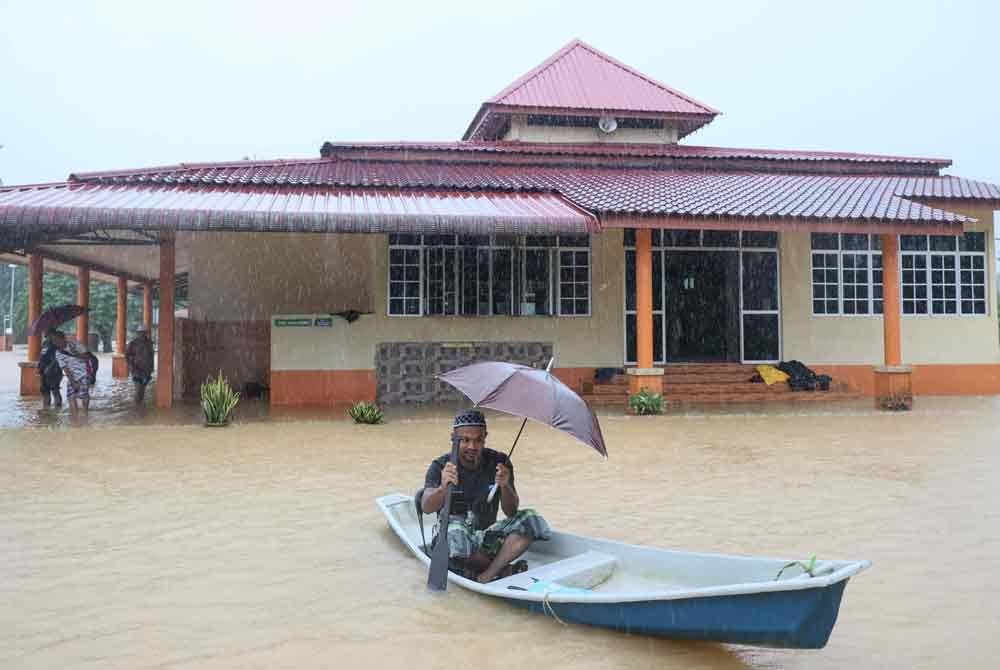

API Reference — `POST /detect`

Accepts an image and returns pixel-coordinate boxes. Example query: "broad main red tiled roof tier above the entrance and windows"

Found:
[62,154,1000,222]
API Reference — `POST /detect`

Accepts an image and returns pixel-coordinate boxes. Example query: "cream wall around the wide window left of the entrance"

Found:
[197,231,625,370]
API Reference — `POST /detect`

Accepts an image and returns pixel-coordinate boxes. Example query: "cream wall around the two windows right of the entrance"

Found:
[780,205,1000,365]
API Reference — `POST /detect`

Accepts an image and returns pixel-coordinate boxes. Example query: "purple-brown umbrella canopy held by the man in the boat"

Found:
[438,361,608,458]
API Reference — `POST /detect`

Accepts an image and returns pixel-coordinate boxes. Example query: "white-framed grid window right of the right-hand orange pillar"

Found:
[899,232,987,316]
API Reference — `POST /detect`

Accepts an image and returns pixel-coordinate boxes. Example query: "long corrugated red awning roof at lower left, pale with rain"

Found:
[0,183,598,235]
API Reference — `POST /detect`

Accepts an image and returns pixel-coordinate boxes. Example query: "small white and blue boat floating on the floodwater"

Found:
[376,493,871,649]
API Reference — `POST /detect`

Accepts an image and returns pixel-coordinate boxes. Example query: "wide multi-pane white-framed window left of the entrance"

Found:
[389,234,590,316]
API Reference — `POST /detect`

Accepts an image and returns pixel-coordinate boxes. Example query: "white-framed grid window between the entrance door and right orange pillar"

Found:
[810,233,882,316]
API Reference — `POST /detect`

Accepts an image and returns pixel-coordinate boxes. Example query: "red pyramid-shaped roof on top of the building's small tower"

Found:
[464,40,719,139]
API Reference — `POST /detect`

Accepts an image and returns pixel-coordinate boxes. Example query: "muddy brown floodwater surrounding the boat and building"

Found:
[0,352,1000,670]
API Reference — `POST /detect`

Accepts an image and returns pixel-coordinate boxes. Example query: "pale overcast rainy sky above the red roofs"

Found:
[0,0,1000,189]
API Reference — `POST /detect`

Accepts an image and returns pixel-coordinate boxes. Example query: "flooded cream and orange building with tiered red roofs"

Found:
[0,41,1000,406]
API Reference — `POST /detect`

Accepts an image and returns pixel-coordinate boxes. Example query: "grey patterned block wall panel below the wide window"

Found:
[375,342,552,405]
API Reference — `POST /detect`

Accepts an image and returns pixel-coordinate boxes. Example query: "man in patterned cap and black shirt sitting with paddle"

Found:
[421,410,551,583]
